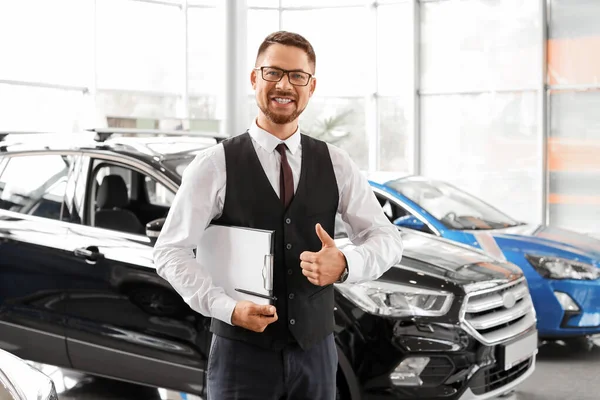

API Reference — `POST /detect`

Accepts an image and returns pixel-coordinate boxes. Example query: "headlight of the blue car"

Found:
[525,255,600,280]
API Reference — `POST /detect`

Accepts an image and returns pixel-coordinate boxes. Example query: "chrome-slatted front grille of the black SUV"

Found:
[462,278,536,345]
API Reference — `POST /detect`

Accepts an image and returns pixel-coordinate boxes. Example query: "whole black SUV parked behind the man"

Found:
[0,129,537,400]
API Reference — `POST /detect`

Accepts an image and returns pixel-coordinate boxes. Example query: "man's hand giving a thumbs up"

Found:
[300,224,346,286]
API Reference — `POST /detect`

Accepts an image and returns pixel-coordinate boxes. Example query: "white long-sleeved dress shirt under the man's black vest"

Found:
[154,121,403,324]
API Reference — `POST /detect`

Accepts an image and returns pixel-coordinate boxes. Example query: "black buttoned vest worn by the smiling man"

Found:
[211,133,339,349]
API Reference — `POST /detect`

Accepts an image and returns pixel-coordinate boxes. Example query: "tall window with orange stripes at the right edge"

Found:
[547,0,600,233]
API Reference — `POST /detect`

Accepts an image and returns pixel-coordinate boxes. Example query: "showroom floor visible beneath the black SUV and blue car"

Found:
[45,340,600,400]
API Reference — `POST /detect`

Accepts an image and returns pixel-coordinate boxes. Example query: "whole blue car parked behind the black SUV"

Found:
[369,176,600,339]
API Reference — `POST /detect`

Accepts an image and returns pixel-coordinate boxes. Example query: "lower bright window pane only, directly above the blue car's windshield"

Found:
[421,93,542,222]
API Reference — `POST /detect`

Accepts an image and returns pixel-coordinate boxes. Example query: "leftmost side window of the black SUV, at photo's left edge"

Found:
[0,154,72,220]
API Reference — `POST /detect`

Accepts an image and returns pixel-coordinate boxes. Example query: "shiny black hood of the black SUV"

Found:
[358,230,522,286]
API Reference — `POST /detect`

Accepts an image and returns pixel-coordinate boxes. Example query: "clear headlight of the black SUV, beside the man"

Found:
[336,281,454,317]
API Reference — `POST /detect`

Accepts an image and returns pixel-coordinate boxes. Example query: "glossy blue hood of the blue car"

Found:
[473,224,600,266]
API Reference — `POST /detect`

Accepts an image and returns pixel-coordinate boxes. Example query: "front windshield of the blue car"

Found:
[386,178,520,230]
